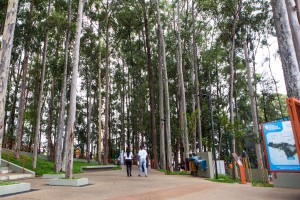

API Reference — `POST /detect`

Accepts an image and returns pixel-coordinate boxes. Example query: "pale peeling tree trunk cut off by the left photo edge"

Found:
[0,0,19,165]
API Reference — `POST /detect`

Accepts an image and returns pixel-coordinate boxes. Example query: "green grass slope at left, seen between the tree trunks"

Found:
[1,152,98,176]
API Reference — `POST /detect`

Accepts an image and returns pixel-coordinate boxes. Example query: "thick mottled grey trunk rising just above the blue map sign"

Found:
[271,0,300,99]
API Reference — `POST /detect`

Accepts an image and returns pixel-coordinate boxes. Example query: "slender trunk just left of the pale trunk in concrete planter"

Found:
[58,0,72,173]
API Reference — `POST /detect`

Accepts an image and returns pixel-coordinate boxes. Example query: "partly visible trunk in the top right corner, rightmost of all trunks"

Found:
[285,0,300,69]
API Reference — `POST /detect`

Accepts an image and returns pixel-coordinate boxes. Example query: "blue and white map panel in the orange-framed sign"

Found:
[262,121,300,171]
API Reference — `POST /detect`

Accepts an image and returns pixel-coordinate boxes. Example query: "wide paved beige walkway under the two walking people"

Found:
[1,167,300,200]
